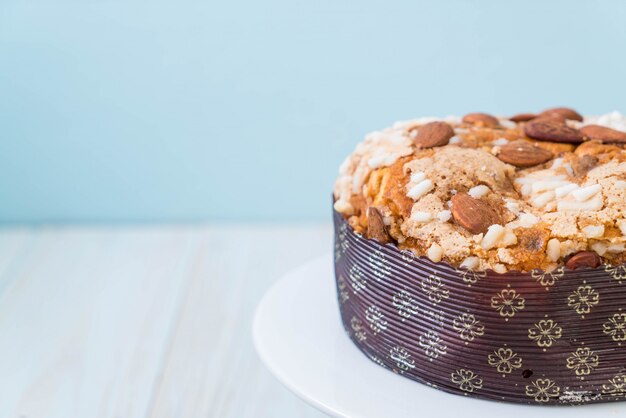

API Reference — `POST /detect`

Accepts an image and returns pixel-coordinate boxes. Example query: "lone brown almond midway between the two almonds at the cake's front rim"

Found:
[451,193,502,234]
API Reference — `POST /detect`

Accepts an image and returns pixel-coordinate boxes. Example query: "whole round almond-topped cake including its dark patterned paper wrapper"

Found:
[333,108,626,404]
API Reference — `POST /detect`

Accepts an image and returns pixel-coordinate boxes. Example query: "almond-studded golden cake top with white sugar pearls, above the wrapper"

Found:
[334,108,626,273]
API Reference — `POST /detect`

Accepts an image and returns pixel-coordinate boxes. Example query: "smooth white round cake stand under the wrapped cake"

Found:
[253,255,626,418]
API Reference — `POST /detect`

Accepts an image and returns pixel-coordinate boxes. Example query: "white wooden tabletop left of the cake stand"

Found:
[0,224,332,418]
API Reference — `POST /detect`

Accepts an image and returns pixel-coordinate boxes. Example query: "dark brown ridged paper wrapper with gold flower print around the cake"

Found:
[334,212,626,405]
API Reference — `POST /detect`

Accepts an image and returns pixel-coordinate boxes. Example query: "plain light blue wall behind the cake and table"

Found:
[0,0,626,222]
